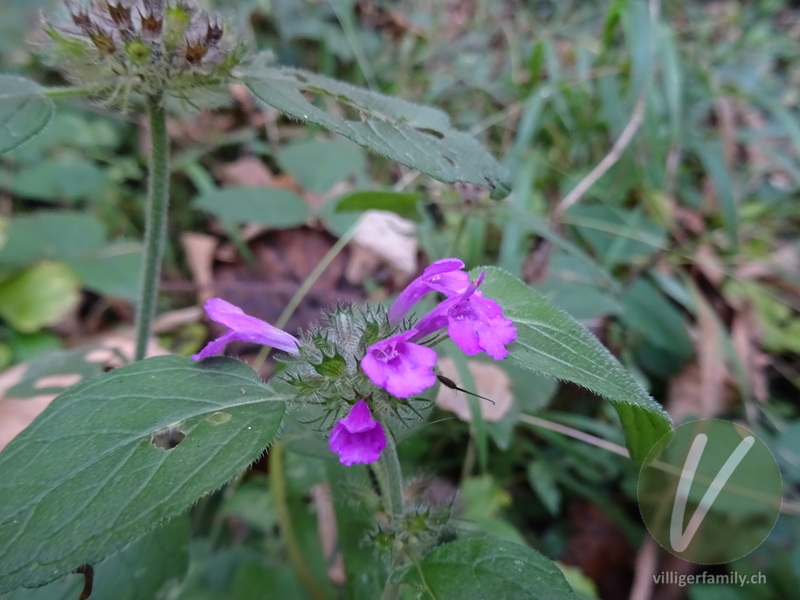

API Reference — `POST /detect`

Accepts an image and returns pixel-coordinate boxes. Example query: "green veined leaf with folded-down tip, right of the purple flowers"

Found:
[473,267,670,463]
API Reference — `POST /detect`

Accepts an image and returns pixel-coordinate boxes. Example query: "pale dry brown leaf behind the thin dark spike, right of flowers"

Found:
[436,358,514,422]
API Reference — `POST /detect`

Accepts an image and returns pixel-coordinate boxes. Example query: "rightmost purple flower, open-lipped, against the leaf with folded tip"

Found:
[410,273,517,360]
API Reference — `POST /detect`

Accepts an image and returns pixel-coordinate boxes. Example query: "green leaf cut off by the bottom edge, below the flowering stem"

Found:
[401,538,577,600]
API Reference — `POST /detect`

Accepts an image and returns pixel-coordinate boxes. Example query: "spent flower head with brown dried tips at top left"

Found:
[43,0,244,110]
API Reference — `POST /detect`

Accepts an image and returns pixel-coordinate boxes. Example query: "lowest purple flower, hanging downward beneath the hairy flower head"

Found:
[328,400,386,467]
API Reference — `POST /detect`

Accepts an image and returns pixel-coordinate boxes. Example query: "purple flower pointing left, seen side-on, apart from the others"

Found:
[192,298,300,360]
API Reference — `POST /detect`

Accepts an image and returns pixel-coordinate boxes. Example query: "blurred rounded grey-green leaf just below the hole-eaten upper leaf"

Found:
[277,139,366,193]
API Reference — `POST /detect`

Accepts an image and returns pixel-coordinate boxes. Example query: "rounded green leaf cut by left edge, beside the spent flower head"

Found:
[0,75,55,154]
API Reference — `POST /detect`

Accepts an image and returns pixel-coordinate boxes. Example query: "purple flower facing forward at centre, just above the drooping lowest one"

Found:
[361,329,436,398]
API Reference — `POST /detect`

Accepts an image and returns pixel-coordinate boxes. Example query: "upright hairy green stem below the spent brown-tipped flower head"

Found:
[134,94,169,360]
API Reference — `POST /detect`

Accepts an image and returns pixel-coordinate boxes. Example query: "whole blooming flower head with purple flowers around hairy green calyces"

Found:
[194,258,517,465]
